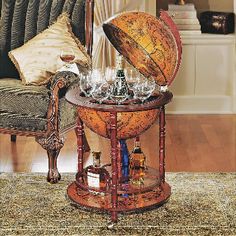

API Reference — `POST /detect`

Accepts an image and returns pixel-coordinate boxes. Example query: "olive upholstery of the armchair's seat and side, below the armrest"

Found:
[0,78,77,131]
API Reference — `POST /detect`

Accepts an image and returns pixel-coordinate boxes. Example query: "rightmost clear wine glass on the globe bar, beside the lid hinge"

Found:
[133,78,156,103]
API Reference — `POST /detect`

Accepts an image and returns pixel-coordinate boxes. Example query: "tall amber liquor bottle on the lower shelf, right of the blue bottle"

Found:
[129,137,146,184]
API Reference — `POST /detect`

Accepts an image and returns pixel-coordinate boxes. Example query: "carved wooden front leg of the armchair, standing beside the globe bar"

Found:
[36,134,64,183]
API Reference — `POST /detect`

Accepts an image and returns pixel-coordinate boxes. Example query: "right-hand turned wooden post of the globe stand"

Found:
[159,106,166,184]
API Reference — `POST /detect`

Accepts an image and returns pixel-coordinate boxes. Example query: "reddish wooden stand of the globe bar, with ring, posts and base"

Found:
[66,87,173,225]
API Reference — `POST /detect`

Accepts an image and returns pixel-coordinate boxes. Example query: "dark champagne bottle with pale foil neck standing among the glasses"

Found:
[110,55,129,104]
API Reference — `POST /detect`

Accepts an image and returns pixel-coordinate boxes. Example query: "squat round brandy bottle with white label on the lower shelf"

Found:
[85,152,110,193]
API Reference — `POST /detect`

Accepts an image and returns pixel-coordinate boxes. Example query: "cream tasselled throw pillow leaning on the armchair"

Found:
[8,13,91,85]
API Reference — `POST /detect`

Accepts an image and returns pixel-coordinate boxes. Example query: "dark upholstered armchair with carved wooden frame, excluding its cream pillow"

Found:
[0,0,94,183]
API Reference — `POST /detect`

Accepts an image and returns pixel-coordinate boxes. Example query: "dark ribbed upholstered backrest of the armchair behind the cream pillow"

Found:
[0,0,85,78]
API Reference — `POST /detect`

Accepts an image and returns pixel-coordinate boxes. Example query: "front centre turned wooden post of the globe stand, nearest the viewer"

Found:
[110,112,118,222]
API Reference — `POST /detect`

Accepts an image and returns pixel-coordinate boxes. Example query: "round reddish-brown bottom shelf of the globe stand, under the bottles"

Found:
[67,182,171,212]
